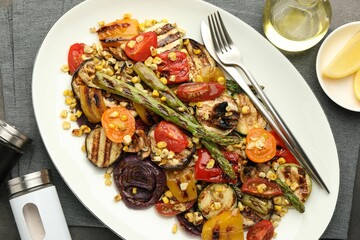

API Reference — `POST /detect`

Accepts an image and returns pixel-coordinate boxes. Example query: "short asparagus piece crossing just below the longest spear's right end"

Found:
[201,139,236,179]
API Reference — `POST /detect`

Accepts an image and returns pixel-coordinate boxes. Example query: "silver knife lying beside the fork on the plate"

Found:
[201,21,329,193]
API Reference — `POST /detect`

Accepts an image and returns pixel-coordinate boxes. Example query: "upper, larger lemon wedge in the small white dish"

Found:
[323,32,360,78]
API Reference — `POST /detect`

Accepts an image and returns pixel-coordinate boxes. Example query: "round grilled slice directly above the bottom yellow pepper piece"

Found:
[198,183,237,219]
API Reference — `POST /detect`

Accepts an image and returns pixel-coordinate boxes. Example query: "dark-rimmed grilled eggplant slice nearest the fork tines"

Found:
[184,39,216,81]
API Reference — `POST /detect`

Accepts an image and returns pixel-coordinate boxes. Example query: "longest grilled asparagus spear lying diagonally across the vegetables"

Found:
[94,72,240,146]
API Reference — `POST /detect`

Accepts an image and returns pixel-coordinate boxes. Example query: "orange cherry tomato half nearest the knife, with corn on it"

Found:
[245,128,276,163]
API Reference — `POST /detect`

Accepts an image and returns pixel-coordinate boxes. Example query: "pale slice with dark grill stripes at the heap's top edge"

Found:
[145,21,185,53]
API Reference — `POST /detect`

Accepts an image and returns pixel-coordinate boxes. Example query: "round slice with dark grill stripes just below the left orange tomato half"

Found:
[85,127,122,168]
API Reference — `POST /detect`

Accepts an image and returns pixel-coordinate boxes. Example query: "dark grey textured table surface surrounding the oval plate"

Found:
[0,0,360,239]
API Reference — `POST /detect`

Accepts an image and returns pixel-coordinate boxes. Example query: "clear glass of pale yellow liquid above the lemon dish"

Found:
[263,0,332,52]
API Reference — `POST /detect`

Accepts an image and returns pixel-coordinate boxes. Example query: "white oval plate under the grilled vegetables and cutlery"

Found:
[32,0,339,240]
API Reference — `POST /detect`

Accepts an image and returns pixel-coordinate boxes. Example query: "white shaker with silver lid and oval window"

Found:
[8,169,71,240]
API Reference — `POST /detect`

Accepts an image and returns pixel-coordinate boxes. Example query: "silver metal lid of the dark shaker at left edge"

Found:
[0,119,31,149]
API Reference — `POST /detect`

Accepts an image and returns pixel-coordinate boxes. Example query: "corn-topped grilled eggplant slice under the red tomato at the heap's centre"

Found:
[148,126,196,170]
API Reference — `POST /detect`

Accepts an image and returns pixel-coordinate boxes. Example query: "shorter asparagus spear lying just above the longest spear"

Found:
[133,62,197,122]
